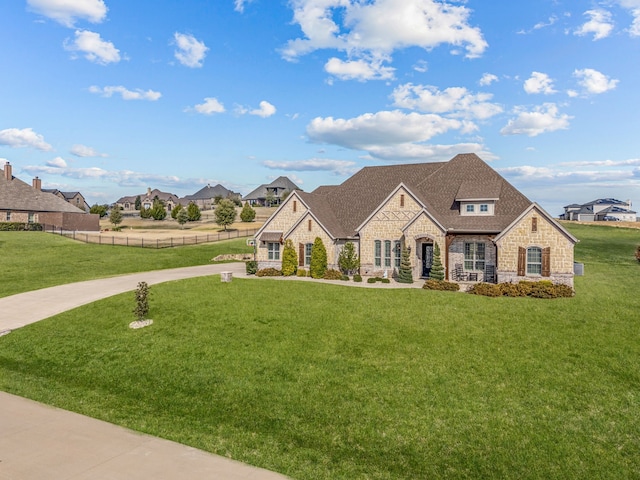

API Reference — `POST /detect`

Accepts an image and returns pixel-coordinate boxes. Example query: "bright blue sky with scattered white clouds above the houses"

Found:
[0,0,640,215]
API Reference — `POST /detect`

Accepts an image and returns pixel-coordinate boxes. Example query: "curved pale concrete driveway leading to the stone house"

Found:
[0,262,246,333]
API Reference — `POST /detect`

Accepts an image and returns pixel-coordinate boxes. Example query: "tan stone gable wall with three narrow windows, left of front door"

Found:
[358,189,422,277]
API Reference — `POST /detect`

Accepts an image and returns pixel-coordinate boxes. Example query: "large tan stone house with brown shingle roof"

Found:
[255,154,577,286]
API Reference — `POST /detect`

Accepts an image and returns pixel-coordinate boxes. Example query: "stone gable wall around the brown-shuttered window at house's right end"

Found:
[496,209,574,287]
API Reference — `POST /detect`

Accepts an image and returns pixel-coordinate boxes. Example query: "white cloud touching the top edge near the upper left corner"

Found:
[27,0,107,28]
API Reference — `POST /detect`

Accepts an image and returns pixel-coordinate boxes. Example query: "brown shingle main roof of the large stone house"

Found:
[301,154,531,238]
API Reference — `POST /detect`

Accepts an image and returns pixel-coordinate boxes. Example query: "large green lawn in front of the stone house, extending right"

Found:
[0,225,640,480]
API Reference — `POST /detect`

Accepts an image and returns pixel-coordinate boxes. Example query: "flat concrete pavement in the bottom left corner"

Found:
[0,392,287,480]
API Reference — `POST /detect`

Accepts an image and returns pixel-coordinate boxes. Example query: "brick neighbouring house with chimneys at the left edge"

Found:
[0,162,100,231]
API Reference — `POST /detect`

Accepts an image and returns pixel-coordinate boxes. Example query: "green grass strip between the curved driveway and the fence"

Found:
[0,232,251,297]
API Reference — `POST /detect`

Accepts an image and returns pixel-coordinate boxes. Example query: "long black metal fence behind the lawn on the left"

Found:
[43,225,258,248]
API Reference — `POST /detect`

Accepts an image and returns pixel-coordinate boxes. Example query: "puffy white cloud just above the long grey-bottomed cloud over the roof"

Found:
[391,83,502,120]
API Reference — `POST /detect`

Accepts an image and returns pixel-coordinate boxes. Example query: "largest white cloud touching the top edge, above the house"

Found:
[281,0,487,80]
